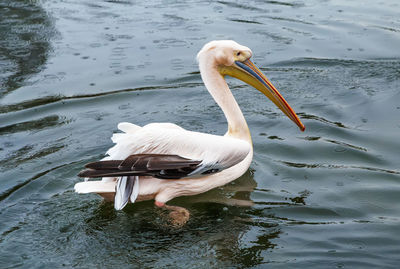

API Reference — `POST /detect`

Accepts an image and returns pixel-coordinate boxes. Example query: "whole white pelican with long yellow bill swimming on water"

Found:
[75,40,305,222]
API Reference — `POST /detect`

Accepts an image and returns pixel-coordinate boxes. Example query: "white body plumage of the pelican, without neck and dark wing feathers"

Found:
[75,122,253,203]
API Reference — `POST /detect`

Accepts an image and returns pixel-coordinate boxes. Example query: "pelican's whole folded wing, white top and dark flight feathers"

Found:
[79,123,251,179]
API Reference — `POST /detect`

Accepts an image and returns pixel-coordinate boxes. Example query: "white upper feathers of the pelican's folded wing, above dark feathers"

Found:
[106,123,251,177]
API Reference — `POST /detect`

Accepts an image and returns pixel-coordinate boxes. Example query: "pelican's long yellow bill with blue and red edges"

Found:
[219,60,306,131]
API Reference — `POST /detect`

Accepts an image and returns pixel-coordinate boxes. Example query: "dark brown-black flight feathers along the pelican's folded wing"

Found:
[78,154,201,179]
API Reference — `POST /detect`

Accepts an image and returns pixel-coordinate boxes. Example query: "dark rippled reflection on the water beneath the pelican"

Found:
[86,169,281,267]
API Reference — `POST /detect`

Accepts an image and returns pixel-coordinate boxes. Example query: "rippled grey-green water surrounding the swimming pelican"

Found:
[0,0,400,268]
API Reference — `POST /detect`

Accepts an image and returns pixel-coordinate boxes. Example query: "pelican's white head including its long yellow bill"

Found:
[197,40,305,131]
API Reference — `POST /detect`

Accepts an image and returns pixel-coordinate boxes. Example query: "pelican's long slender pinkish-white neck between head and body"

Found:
[199,59,252,144]
